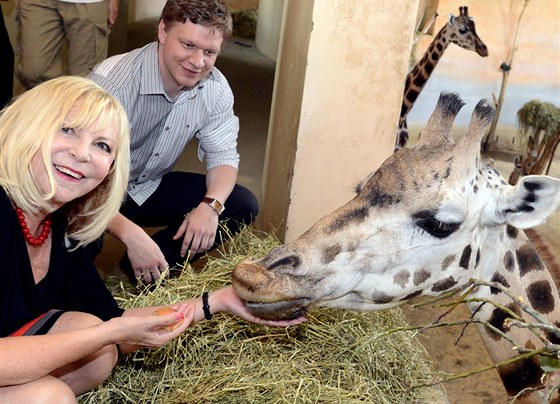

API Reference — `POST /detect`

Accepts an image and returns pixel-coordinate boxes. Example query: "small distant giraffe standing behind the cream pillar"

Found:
[395,7,488,150]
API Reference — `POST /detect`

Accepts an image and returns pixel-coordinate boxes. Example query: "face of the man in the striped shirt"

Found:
[158,20,224,97]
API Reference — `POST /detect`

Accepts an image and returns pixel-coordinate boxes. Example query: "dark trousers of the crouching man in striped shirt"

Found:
[121,171,259,266]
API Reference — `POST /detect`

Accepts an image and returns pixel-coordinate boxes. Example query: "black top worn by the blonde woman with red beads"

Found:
[0,187,124,337]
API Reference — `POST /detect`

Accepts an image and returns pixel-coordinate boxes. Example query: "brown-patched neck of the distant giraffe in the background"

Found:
[400,25,451,122]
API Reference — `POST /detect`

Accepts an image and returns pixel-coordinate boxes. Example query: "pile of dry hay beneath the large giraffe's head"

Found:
[79,230,437,404]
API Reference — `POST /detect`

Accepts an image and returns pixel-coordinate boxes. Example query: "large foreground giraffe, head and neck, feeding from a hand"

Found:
[232,93,560,402]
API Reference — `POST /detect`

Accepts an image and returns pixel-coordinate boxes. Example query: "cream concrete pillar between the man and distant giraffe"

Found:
[262,0,418,241]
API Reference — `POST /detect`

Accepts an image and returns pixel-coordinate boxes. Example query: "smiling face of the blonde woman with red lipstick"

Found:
[31,107,117,208]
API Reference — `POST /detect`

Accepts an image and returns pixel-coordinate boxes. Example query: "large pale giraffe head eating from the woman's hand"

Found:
[232,93,560,319]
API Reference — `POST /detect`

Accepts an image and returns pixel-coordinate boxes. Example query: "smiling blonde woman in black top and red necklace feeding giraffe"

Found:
[0,77,303,403]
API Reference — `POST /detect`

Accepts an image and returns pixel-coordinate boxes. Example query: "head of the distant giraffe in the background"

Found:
[442,6,488,56]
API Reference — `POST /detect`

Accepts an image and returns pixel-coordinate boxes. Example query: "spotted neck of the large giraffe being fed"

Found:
[469,226,560,395]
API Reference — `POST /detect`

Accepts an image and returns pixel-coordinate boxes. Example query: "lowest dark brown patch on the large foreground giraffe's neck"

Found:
[498,357,543,396]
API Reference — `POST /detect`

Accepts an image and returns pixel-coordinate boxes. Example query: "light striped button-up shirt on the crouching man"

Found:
[89,42,239,205]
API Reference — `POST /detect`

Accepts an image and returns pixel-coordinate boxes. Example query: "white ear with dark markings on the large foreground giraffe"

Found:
[500,175,560,229]
